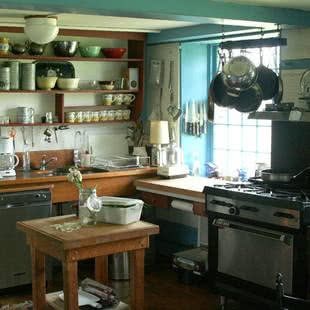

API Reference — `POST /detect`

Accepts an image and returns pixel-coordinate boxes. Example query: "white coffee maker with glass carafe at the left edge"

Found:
[0,136,19,178]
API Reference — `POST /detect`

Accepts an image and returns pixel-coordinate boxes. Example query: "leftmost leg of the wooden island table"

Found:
[31,246,46,310]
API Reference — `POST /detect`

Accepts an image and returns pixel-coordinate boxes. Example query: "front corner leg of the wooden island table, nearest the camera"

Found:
[62,261,79,310]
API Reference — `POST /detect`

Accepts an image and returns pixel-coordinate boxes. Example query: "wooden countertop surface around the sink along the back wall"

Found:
[0,168,156,189]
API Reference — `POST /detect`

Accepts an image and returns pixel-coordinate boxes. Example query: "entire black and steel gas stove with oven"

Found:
[204,181,310,309]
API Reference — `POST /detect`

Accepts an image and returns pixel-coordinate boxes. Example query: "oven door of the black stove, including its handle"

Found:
[213,218,293,293]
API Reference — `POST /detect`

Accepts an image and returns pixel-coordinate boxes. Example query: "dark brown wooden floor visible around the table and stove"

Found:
[0,261,262,310]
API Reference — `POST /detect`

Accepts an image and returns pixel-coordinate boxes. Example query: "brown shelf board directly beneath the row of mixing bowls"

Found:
[0,54,144,62]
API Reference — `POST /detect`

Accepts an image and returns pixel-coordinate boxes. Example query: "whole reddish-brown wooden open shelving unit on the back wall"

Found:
[0,26,146,127]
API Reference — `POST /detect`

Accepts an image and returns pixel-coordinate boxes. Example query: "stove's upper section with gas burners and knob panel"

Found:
[204,182,310,229]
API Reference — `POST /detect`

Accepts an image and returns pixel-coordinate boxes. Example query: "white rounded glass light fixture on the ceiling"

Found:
[24,15,59,44]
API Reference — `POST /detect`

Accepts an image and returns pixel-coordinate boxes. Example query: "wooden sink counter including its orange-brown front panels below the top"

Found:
[0,168,156,203]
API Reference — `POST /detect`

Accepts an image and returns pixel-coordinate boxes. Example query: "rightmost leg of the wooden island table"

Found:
[130,249,144,310]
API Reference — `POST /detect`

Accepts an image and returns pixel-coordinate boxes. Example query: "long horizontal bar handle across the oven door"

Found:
[212,219,293,245]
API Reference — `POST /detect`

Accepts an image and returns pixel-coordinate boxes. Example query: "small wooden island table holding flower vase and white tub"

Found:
[17,215,159,310]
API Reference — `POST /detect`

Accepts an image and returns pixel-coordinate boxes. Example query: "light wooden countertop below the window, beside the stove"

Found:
[135,176,223,202]
